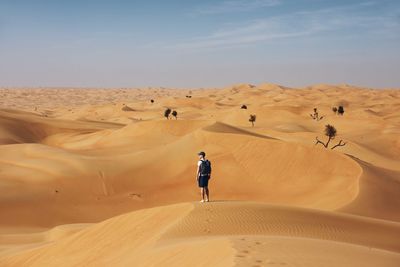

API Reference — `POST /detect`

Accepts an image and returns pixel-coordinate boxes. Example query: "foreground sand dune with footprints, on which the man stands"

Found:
[0,202,400,266]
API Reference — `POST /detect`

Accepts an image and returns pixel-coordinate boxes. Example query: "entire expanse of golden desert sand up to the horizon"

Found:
[0,84,400,267]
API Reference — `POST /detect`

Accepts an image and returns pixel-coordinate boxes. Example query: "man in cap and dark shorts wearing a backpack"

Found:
[196,151,211,202]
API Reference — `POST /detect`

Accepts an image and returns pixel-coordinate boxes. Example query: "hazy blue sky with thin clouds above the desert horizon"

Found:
[0,0,400,88]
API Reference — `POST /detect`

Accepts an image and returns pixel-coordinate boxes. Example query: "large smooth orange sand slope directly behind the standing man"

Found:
[0,121,362,226]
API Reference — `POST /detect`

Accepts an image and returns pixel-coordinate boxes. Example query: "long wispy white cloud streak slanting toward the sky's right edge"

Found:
[168,1,398,51]
